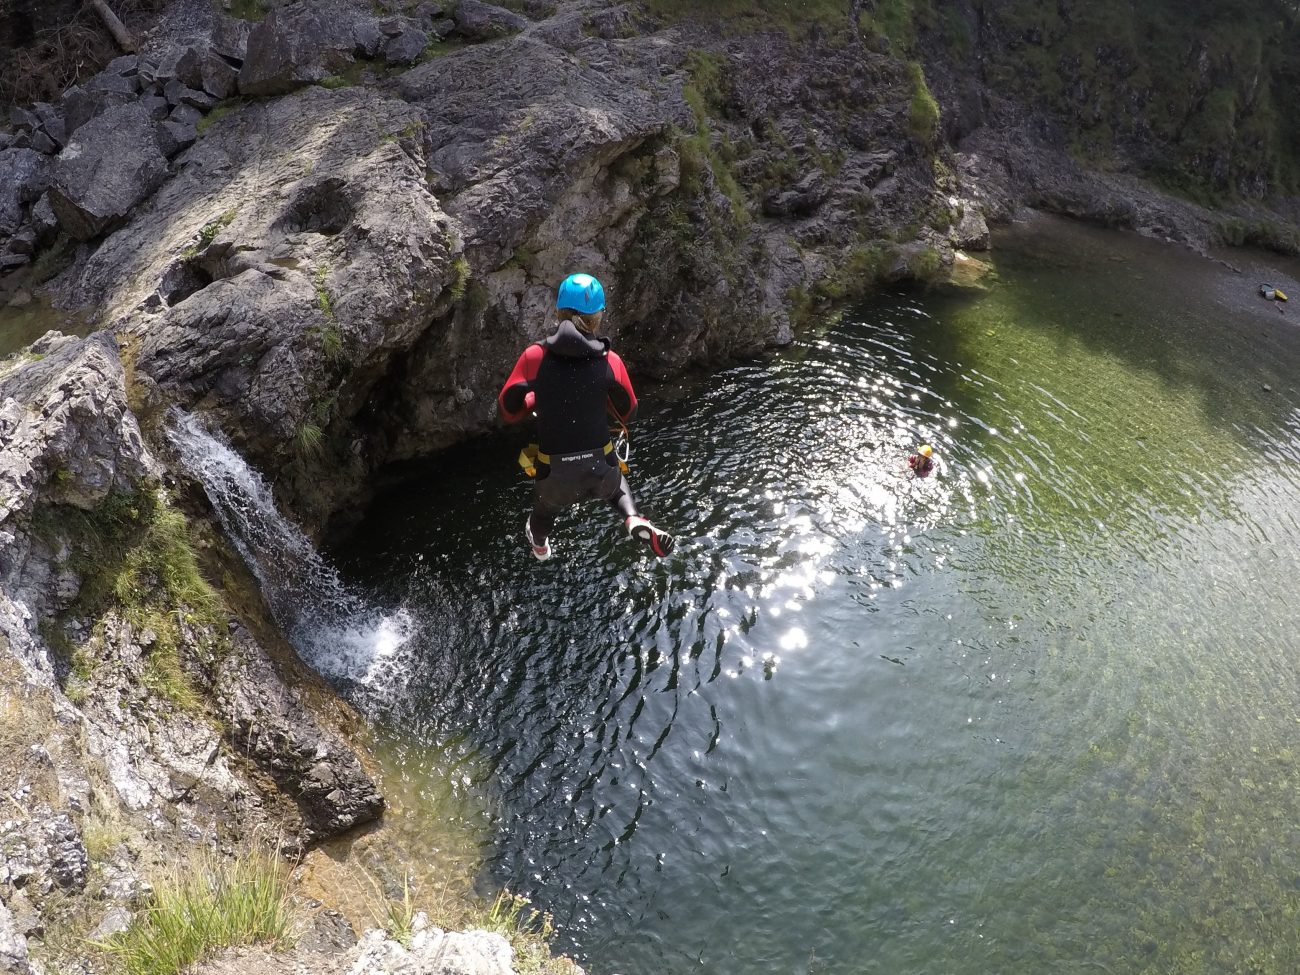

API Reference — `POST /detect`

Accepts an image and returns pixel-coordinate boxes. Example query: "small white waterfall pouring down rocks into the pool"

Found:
[166,411,413,706]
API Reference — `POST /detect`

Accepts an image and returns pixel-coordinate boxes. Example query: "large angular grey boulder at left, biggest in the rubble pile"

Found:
[49,103,170,241]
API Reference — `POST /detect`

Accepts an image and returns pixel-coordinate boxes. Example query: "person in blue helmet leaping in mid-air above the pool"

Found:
[497,274,676,560]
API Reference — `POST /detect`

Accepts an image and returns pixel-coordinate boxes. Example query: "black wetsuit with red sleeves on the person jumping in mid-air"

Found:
[498,321,637,543]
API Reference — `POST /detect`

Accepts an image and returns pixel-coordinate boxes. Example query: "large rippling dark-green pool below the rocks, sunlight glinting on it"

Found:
[334,220,1300,975]
